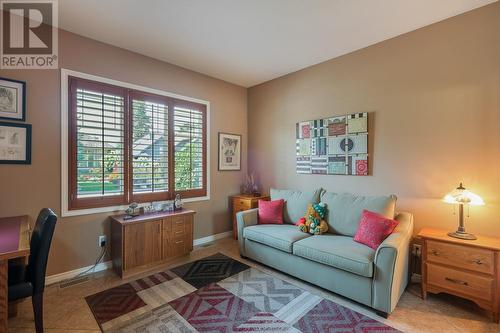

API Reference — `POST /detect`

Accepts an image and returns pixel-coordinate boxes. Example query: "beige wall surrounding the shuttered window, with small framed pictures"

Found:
[0,31,247,275]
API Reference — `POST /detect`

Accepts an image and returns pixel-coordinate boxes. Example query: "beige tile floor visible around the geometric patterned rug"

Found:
[9,238,500,333]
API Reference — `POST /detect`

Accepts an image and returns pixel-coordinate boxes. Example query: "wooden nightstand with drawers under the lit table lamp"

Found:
[418,228,500,323]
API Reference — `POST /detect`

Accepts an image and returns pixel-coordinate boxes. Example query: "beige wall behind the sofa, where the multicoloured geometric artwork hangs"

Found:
[248,3,500,236]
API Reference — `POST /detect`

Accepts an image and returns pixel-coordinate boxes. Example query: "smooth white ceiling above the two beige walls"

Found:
[59,0,496,87]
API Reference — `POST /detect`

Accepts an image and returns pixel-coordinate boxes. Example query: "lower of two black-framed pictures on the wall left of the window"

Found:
[0,121,31,164]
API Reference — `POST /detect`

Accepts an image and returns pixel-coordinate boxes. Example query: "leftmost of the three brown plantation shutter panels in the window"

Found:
[70,80,126,207]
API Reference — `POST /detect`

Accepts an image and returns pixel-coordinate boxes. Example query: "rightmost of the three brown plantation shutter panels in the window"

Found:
[174,103,206,196]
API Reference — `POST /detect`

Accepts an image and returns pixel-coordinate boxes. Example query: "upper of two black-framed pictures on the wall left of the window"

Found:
[0,78,26,121]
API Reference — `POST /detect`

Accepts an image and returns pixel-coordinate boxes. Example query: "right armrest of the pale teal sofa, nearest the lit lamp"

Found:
[372,213,413,314]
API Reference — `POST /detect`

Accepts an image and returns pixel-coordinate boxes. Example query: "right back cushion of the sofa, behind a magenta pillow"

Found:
[321,192,396,237]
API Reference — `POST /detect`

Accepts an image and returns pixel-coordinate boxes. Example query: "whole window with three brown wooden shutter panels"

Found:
[68,76,207,210]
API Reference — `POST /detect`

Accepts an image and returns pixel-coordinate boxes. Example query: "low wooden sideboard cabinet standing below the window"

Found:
[111,209,195,278]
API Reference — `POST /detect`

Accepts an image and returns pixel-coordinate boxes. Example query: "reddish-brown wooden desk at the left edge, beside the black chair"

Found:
[0,216,30,332]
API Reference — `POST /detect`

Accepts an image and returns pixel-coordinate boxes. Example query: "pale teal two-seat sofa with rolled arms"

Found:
[237,189,413,317]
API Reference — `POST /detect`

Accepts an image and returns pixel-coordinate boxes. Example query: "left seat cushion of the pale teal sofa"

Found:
[243,224,311,253]
